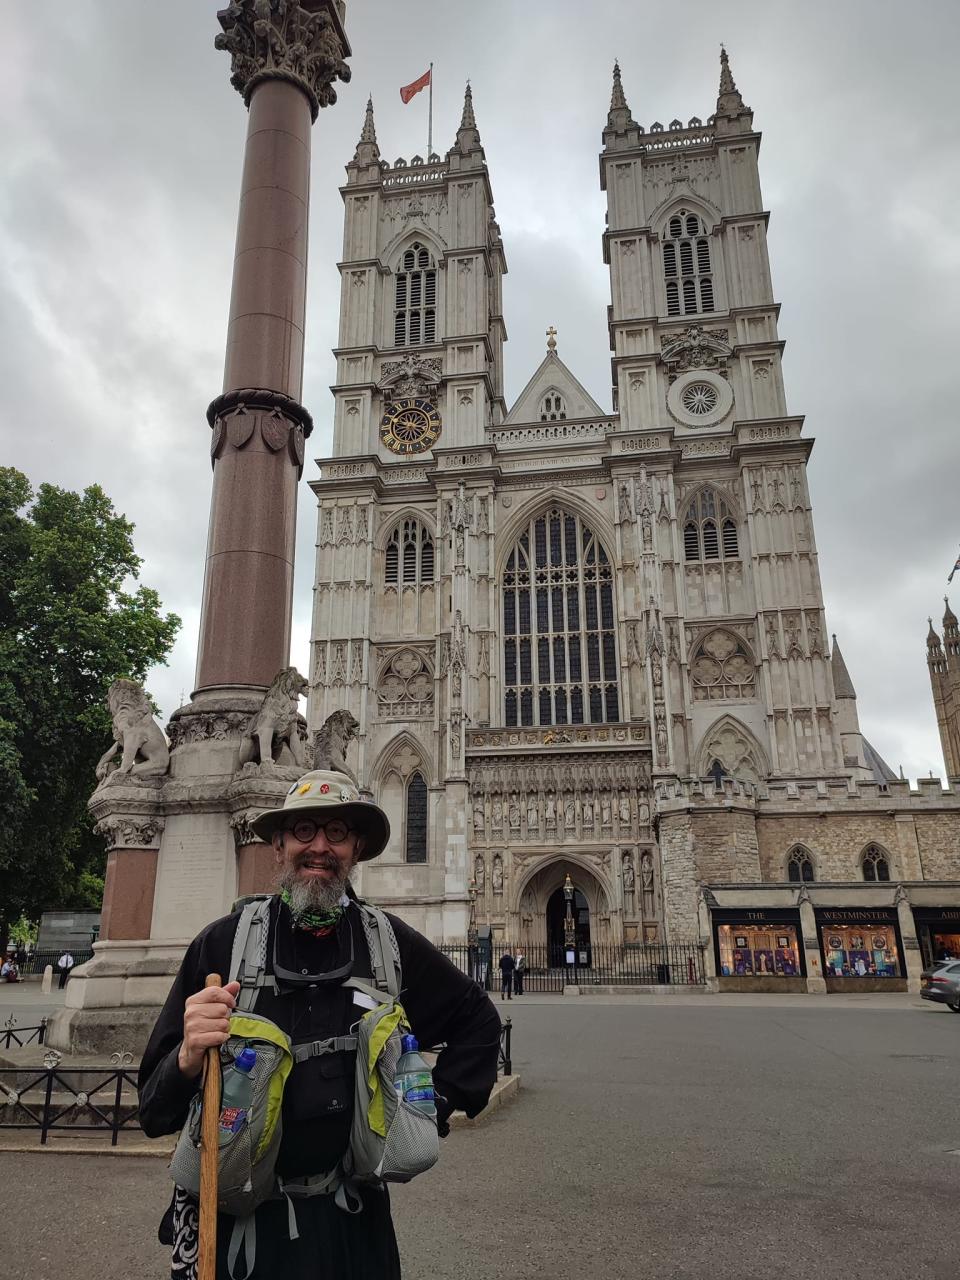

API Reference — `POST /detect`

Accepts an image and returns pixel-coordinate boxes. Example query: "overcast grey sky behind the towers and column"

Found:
[0,0,960,776]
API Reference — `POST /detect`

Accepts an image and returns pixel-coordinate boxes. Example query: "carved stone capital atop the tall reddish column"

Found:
[214,0,351,120]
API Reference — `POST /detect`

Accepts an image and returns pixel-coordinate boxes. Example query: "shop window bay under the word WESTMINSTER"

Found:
[814,906,906,992]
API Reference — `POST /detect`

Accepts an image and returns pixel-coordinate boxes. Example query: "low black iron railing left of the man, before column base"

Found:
[0,1066,140,1147]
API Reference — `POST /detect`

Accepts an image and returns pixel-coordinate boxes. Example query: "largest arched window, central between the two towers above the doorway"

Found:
[503,507,620,724]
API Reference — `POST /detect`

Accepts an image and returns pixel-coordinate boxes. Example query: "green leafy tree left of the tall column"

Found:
[0,467,180,943]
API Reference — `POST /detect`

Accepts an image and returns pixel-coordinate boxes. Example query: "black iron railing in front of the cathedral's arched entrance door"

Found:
[440,942,705,992]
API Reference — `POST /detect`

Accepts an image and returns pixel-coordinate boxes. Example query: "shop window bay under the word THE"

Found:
[712,908,806,991]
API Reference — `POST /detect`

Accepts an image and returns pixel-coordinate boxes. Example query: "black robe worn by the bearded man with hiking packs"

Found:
[140,899,500,1280]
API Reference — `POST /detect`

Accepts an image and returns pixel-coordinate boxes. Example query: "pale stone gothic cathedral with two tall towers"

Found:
[308,54,960,989]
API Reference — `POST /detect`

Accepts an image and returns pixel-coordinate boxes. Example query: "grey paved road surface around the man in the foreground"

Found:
[0,997,960,1280]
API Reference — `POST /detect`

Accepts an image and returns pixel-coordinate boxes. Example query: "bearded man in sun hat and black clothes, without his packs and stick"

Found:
[140,771,500,1280]
